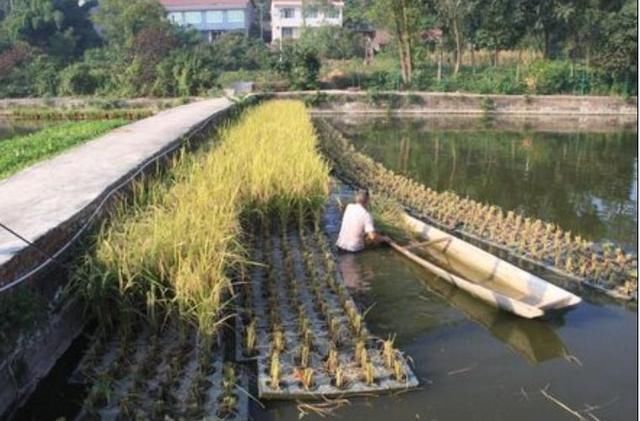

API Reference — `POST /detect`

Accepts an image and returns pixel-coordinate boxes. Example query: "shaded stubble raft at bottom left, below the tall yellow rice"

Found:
[74,323,248,420]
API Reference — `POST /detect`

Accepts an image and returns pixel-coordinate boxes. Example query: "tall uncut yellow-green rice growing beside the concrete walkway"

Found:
[76,101,329,337]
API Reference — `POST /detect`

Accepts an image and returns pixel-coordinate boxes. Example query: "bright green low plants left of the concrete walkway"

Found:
[0,119,127,179]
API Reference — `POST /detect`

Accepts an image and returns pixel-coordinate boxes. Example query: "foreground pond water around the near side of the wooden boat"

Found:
[256,185,638,421]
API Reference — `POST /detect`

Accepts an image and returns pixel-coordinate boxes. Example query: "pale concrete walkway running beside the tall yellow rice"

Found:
[0,98,232,287]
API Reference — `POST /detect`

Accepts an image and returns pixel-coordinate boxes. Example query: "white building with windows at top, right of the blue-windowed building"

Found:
[271,0,344,42]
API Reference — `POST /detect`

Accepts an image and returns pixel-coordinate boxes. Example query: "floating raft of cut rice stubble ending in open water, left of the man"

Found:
[237,213,418,399]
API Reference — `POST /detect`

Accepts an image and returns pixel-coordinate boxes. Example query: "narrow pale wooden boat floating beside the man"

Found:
[391,214,582,319]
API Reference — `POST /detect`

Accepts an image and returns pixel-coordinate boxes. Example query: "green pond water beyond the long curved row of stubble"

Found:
[322,117,638,250]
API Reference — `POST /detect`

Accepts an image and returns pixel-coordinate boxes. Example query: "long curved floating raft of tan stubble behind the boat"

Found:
[316,120,638,300]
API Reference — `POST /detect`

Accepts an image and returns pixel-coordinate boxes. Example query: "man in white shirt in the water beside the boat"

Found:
[336,190,389,252]
